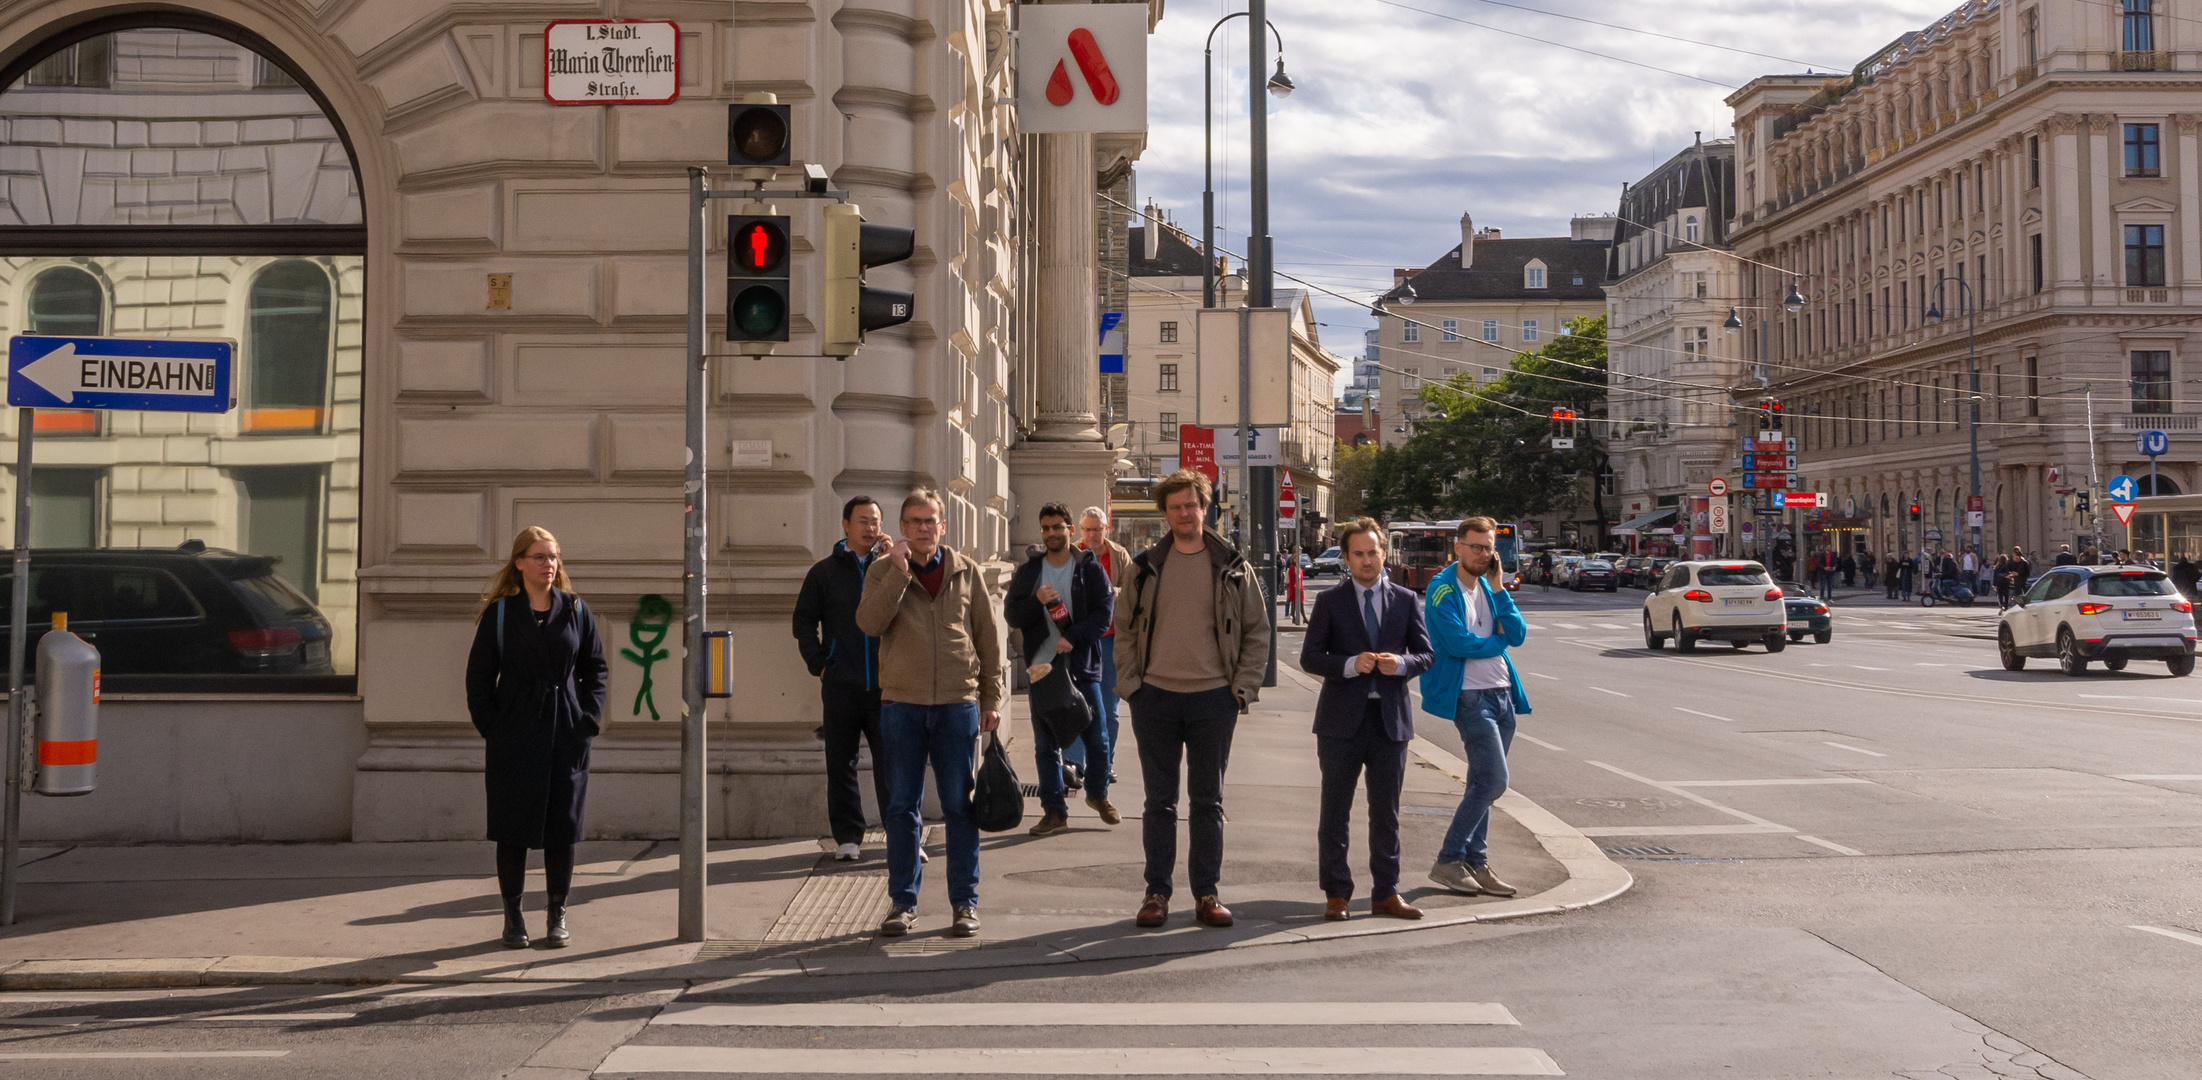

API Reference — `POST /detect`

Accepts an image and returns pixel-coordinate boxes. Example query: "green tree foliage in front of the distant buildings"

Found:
[1363,315,1605,520]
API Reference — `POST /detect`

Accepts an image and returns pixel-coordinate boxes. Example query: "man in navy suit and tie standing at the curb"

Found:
[1299,518,1431,921]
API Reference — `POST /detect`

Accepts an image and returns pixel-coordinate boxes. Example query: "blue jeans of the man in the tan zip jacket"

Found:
[879,701,978,910]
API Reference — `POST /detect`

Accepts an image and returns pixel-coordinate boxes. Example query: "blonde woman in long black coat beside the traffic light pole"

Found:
[467,525,606,948]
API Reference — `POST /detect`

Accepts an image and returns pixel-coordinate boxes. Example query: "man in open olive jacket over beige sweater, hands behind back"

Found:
[1116,469,1268,928]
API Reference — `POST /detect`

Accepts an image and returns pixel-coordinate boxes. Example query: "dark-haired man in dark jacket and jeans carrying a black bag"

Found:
[1002,503,1123,835]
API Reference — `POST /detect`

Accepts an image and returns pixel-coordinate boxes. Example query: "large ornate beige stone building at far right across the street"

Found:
[1729,0,2202,551]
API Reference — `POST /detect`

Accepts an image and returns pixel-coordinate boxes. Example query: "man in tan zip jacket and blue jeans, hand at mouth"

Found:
[857,487,1002,937]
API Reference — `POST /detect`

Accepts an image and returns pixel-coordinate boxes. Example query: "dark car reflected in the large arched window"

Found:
[0,540,335,677]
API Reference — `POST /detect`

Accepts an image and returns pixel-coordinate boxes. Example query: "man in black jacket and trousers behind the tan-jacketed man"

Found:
[795,496,887,862]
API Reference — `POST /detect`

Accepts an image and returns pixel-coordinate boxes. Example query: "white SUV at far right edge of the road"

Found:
[1995,566,2195,674]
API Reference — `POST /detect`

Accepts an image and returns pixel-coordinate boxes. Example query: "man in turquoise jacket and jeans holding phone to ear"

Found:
[1422,518,1528,897]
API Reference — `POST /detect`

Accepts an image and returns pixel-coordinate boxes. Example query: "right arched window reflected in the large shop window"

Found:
[242,260,333,432]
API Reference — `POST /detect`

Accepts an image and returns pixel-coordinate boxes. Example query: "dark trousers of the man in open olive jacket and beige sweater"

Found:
[1125,685,1238,897]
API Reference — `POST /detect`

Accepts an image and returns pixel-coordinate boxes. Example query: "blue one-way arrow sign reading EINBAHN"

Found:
[7,335,236,412]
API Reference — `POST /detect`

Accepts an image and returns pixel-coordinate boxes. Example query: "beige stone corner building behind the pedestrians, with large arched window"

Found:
[0,0,1160,840]
